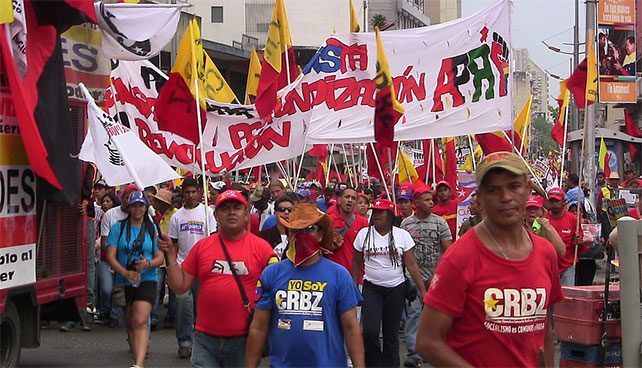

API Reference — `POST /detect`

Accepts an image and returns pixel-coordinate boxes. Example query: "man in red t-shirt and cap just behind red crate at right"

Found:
[546,188,582,286]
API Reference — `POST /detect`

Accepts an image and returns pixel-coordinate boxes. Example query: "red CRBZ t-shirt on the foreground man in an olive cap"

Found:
[424,231,563,367]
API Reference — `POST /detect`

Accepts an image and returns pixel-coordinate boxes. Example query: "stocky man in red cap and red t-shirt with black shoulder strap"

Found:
[158,190,278,367]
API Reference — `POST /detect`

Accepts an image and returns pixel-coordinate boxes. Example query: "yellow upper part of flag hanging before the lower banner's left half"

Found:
[171,19,205,109]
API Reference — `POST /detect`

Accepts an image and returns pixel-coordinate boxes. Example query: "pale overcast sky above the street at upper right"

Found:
[462,0,586,101]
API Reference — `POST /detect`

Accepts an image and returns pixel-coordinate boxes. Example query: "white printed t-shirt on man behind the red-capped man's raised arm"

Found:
[168,203,216,264]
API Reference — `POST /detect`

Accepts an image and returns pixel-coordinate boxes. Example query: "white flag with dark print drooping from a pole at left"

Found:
[79,83,179,187]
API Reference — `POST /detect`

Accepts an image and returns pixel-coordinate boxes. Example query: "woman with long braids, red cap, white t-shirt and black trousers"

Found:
[352,199,426,367]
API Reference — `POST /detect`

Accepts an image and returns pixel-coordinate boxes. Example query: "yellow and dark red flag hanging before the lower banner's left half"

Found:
[155,19,207,144]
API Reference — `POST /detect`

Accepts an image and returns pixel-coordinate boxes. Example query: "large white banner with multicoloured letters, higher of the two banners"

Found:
[275,0,513,144]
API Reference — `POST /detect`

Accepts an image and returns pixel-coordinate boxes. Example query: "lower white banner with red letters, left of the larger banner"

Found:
[105,61,312,174]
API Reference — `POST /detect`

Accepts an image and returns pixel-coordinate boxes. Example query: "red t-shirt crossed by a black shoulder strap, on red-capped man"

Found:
[181,232,277,337]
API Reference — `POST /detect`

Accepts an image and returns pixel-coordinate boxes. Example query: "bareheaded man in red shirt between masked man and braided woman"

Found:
[328,183,368,272]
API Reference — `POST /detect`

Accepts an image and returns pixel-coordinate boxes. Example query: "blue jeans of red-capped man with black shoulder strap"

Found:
[190,331,247,367]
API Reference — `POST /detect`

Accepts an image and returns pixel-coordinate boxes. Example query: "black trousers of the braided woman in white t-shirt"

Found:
[361,281,406,367]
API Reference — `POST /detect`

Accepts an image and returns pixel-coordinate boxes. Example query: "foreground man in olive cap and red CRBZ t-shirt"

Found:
[416,152,563,367]
